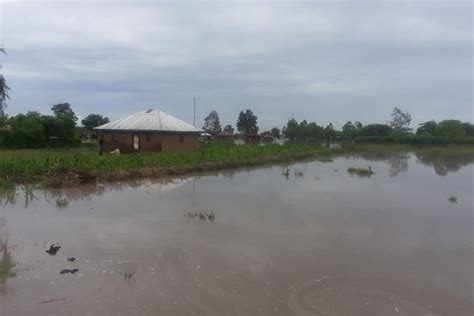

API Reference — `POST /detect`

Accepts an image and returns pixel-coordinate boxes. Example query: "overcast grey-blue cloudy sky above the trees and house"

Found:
[0,0,473,129]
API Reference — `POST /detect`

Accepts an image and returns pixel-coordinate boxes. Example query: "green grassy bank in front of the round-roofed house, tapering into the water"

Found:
[0,144,340,188]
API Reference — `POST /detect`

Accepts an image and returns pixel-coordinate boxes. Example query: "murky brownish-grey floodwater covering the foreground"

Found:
[0,147,474,316]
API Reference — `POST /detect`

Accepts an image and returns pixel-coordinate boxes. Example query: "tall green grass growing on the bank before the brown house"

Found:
[0,144,335,186]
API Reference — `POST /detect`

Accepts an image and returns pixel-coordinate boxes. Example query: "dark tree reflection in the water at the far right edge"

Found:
[415,148,474,176]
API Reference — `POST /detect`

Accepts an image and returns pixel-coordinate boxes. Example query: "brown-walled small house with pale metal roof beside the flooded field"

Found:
[94,110,202,153]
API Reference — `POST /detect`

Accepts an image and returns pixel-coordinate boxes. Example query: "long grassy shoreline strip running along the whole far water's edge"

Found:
[0,143,474,192]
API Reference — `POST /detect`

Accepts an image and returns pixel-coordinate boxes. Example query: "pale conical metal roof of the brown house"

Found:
[95,110,202,133]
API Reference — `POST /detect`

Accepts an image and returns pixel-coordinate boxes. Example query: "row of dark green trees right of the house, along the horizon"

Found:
[203,107,474,143]
